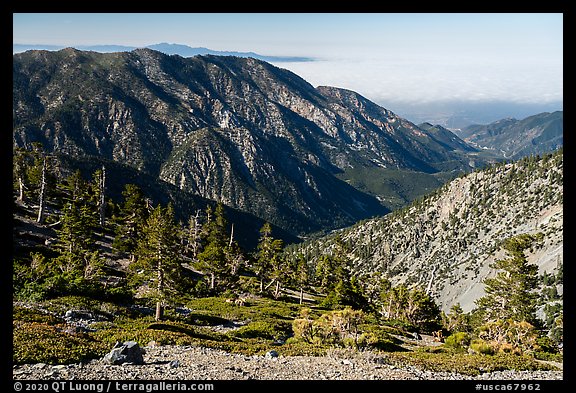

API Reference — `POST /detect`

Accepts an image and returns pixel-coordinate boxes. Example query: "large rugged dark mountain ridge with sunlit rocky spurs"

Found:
[13,48,482,235]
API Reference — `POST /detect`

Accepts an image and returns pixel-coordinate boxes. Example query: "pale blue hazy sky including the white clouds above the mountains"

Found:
[13,13,563,108]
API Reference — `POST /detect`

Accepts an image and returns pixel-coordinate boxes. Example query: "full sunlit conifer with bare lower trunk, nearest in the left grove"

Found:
[129,204,182,321]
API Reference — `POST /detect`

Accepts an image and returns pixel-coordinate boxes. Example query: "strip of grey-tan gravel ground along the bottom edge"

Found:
[12,346,563,380]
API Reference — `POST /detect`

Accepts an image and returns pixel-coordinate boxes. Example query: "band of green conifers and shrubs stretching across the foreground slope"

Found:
[13,144,563,364]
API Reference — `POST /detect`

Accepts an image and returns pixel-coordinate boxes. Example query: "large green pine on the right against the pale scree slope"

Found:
[476,234,538,324]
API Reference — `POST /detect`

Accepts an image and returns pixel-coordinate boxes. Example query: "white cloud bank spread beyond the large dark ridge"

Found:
[275,57,563,104]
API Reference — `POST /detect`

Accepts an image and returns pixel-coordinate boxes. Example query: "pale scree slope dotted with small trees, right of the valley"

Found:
[292,150,564,311]
